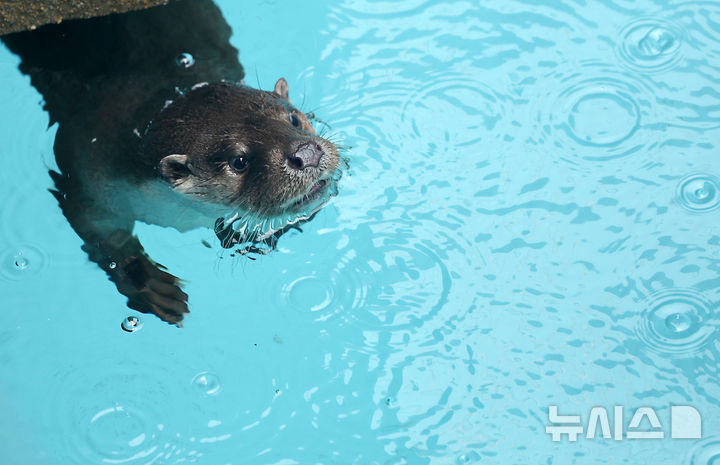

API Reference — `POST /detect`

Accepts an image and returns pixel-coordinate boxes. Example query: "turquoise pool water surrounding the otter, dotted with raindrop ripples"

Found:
[0,0,720,465]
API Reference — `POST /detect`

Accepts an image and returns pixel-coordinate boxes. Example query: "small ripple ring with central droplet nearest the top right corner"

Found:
[617,18,683,72]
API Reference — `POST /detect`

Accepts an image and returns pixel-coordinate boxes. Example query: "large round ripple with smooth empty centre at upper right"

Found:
[538,62,653,161]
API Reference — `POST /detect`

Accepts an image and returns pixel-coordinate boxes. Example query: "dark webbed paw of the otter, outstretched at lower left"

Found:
[114,257,190,326]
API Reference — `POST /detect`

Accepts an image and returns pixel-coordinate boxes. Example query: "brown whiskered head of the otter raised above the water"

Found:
[142,78,339,218]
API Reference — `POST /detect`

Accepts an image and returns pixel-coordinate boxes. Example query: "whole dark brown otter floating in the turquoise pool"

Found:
[2,0,340,325]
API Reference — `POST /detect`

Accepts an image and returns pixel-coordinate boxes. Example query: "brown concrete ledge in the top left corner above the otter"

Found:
[0,0,169,35]
